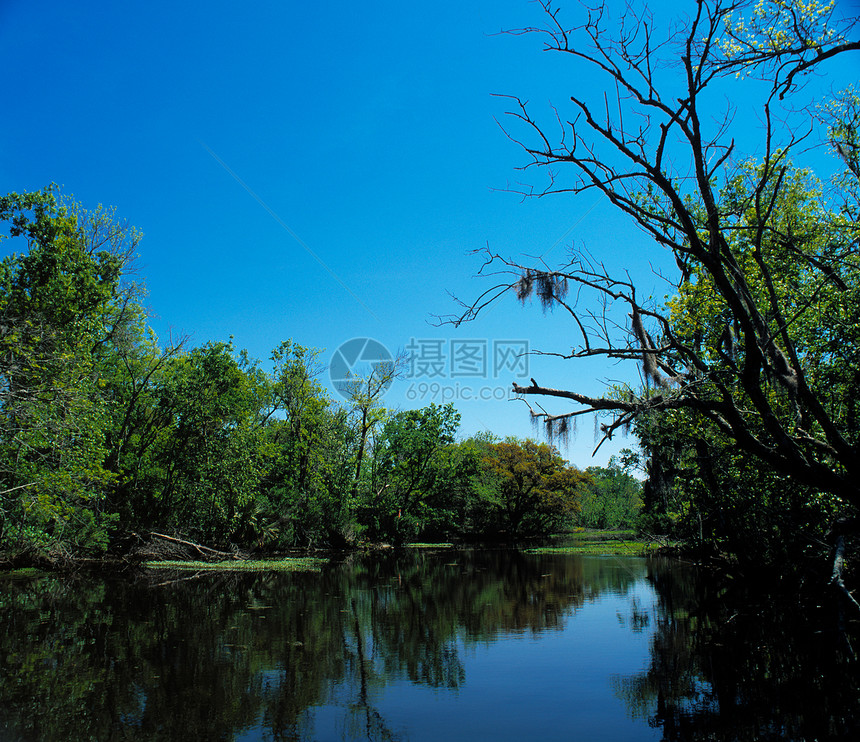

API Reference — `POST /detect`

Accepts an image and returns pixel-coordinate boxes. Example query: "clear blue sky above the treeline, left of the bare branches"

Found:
[0,0,857,467]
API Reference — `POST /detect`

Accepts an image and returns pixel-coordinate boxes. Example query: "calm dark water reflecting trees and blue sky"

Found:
[0,551,860,742]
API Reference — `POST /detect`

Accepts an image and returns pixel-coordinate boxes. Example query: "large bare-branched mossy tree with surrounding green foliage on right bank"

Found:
[454,0,860,581]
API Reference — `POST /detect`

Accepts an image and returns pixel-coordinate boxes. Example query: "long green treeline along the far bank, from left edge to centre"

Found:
[0,189,638,554]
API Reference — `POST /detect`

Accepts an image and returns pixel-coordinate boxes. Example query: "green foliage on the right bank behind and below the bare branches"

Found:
[636,161,860,568]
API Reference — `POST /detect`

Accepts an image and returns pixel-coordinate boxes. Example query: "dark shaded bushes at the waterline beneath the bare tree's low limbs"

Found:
[637,413,845,574]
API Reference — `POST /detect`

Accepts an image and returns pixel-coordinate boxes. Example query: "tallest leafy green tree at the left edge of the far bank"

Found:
[0,188,137,550]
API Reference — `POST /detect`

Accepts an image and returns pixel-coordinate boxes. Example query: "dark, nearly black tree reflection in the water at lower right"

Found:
[614,562,860,742]
